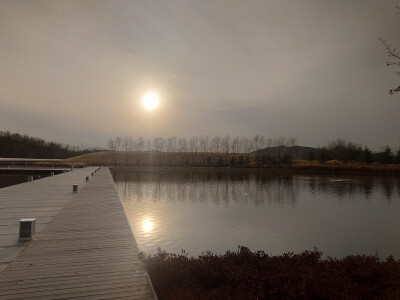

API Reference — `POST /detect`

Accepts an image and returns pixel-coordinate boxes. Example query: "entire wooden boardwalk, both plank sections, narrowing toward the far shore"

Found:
[0,168,156,299]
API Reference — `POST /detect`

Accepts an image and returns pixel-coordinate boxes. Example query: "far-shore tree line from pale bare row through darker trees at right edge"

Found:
[108,134,400,166]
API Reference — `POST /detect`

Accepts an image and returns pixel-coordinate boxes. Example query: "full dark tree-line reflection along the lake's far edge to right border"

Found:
[113,168,400,206]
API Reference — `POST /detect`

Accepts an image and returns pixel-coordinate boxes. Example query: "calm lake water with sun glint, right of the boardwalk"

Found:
[112,168,400,258]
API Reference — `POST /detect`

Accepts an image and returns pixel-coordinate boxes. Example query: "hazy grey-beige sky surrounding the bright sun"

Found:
[0,0,400,149]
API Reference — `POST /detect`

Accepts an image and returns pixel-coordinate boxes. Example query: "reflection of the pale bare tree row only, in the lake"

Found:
[113,169,300,206]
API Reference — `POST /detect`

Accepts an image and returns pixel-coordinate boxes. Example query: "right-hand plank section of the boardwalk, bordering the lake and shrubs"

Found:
[0,168,156,299]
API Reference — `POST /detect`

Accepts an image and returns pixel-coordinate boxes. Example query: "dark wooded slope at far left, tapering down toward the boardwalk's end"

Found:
[0,131,93,158]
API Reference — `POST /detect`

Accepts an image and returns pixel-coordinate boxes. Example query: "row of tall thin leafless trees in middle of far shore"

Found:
[108,134,296,166]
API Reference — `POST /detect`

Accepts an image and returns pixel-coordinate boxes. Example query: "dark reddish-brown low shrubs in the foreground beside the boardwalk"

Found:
[141,247,400,299]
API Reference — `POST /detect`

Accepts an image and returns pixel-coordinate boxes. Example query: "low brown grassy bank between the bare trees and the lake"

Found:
[55,151,400,175]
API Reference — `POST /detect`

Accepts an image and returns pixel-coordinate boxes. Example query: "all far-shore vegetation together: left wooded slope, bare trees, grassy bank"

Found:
[0,131,400,174]
